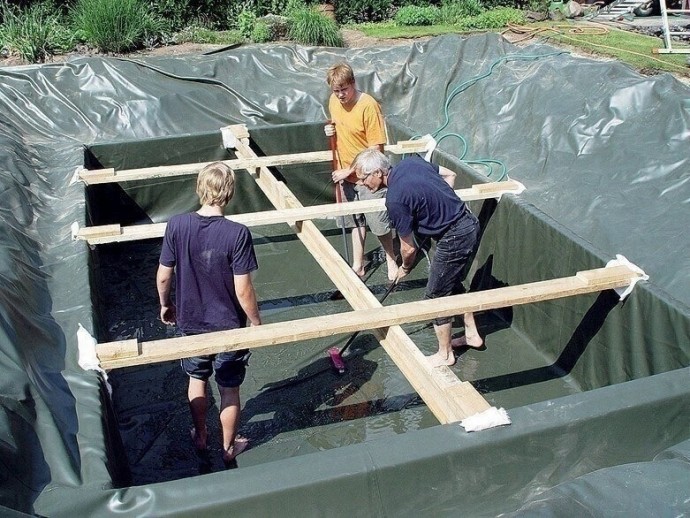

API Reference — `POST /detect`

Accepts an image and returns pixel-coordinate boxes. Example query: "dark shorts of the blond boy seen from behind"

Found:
[178,331,252,388]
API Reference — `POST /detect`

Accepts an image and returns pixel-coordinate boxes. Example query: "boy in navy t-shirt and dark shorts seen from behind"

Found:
[156,162,261,464]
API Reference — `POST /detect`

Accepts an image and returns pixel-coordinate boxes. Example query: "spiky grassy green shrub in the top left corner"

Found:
[0,2,76,63]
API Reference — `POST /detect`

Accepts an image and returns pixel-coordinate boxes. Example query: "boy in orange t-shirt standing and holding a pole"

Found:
[324,63,398,281]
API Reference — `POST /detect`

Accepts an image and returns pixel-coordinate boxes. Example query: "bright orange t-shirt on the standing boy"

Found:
[328,92,386,183]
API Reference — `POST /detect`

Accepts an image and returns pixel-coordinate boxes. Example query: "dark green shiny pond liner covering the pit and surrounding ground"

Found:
[0,35,690,517]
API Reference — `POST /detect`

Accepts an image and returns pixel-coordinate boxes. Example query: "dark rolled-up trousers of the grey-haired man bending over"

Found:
[424,212,479,325]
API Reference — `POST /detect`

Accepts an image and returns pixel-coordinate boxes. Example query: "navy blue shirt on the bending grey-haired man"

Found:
[386,155,465,237]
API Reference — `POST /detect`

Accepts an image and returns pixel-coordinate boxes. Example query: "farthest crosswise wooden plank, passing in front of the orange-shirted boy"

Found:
[79,139,428,185]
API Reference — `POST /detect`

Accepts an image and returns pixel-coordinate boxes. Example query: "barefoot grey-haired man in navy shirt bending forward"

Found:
[353,149,484,366]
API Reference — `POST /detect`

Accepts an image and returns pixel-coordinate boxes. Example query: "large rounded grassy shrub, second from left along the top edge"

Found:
[73,0,165,52]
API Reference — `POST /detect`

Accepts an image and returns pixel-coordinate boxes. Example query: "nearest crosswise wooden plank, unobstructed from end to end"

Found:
[96,265,641,369]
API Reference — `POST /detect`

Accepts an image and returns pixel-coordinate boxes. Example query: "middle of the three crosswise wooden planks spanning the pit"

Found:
[75,180,522,245]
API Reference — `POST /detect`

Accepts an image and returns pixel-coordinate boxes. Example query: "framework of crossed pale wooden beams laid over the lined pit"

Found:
[82,125,641,423]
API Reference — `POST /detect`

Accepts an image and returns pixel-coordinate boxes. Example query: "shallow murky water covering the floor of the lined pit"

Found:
[94,221,577,485]
